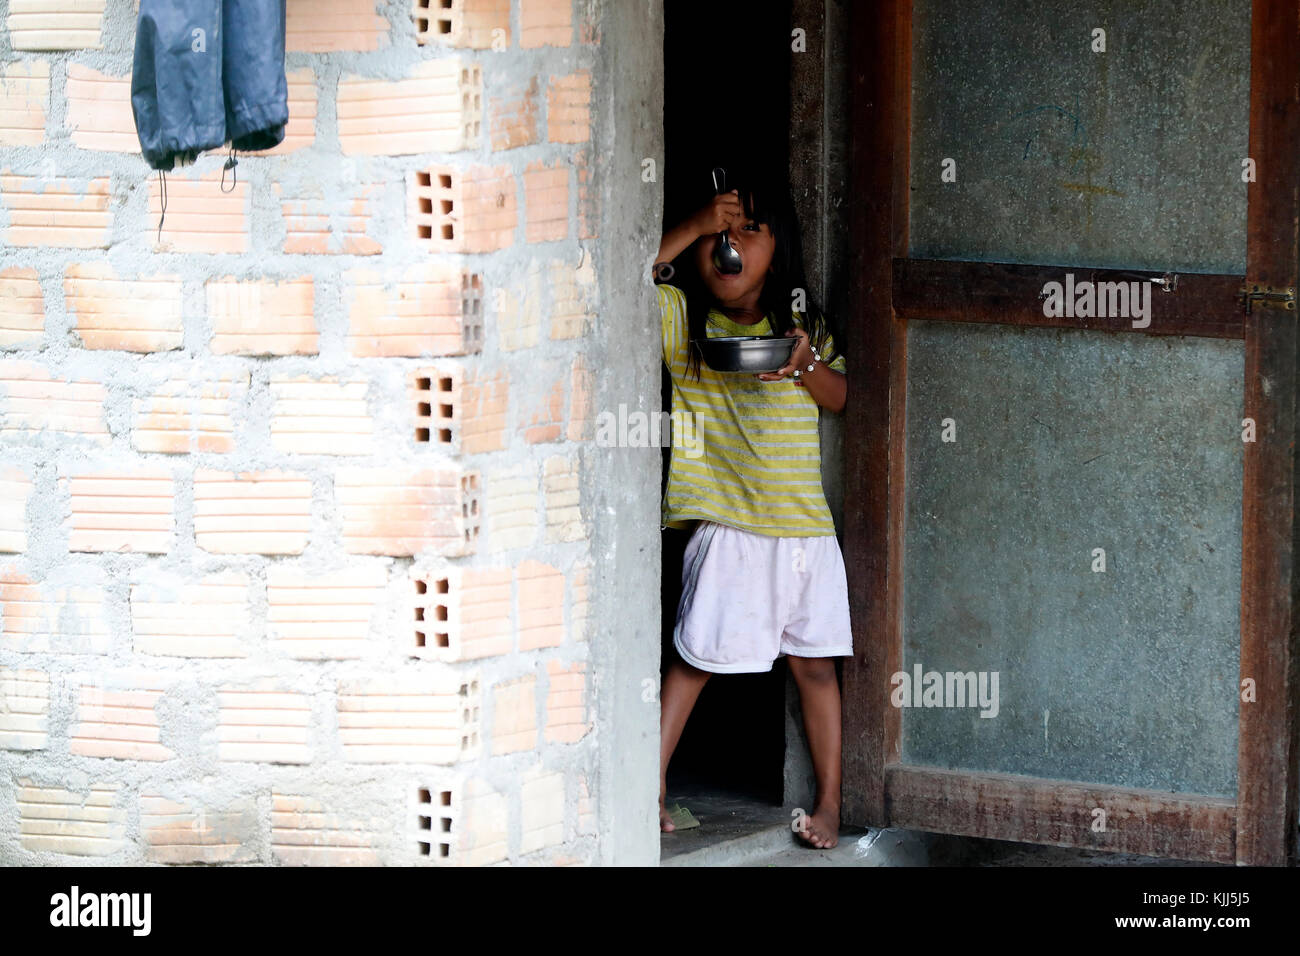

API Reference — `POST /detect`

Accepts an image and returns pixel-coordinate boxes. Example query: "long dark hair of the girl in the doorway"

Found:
[675,168,844,380]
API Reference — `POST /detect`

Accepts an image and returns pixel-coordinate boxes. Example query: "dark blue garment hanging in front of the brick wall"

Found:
[131,0,289,169]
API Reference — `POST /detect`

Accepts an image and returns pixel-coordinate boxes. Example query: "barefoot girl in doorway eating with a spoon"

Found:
[655,166,853,848]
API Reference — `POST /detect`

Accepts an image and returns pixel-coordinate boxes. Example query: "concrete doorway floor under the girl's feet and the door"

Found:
[659,788,1222,866]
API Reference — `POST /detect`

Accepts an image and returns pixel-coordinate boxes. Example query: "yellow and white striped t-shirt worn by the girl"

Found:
[657,285,845,537]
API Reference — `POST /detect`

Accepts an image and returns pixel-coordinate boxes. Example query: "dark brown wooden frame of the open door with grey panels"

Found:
[844,0,1300,865]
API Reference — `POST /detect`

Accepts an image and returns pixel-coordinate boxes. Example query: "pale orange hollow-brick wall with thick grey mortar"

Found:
[0,0,631,865]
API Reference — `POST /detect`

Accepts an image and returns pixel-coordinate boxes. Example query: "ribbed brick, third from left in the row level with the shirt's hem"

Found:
[194,468,312,554]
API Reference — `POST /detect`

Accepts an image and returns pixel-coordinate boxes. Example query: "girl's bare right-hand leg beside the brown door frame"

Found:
[787,657,840,849]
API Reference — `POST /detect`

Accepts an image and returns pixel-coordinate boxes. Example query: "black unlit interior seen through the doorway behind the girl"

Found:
[660,0,790,805]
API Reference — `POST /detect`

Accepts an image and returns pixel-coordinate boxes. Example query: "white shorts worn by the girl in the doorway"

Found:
[672,520,853,674]
